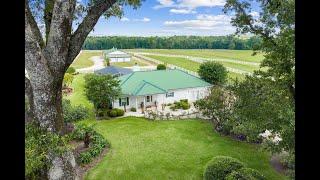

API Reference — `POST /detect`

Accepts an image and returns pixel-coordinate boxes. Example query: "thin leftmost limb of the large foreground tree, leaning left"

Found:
[25,0,44,48]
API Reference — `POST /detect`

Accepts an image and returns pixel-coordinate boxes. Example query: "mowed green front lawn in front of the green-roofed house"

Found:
[80,117,285,180]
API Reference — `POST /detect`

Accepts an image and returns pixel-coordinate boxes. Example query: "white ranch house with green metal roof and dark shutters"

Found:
[113,69,212,110]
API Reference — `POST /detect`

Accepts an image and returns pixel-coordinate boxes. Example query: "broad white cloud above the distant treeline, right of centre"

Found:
[164,14,235,35]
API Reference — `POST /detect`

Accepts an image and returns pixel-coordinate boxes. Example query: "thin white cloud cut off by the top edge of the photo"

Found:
[154,0,226,9]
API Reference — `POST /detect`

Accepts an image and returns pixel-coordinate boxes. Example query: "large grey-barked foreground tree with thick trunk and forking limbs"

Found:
[25,0,140,179]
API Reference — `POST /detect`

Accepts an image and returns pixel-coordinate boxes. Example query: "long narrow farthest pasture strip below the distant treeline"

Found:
[126,49,263,62]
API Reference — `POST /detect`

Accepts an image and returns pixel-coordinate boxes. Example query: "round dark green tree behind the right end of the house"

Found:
[198,61,228,85]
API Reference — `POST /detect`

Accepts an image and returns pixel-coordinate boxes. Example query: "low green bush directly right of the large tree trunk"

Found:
[62,99,89,122]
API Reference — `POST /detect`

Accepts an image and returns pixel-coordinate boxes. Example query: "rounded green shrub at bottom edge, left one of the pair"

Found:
[204,156,244,180]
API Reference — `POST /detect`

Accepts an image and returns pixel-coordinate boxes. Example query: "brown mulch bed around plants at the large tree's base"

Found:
[70,141,109,180]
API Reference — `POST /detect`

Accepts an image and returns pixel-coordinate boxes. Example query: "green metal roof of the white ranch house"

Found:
[119,69,211,96]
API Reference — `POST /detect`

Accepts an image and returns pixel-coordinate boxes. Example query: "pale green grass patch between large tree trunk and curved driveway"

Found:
[71,50,102,69]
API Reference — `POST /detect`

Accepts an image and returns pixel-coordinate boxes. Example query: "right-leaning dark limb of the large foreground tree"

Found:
[66,0,116,68]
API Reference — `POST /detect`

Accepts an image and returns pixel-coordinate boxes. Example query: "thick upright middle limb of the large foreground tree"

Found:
[43,0,76,75]
